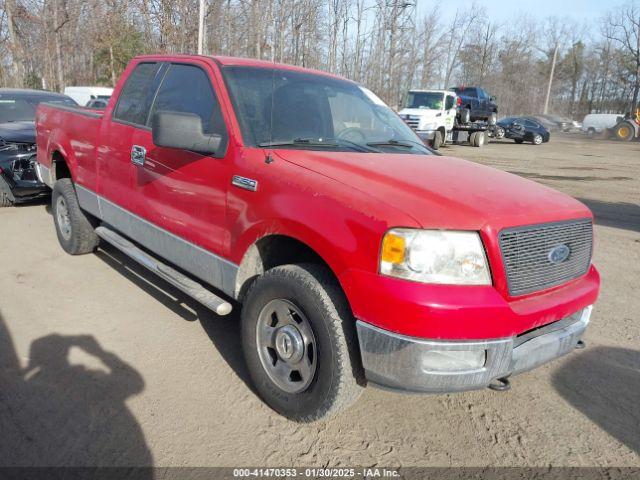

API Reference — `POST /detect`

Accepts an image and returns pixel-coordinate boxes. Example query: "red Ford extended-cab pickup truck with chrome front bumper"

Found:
[36,55,600,421]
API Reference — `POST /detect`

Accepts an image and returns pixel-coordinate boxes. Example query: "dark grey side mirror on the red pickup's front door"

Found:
[151,111,222,154]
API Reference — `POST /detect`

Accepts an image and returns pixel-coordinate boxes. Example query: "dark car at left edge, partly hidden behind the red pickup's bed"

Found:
[0,88,78,207]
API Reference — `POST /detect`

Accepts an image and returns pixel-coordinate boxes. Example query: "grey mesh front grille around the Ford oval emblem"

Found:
[499,219,593,295]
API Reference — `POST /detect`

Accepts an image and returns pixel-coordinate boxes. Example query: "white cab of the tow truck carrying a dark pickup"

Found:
[398,90,457,150]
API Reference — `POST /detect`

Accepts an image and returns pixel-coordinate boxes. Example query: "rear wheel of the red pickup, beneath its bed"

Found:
[51,178,100,255]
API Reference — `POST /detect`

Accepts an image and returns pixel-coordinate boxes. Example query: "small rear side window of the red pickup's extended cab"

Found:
[113,63,160,125]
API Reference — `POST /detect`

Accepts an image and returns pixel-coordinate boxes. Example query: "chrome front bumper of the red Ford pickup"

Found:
[356,306,592,393]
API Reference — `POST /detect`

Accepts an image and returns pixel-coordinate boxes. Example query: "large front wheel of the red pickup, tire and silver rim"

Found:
[242,264,362,422]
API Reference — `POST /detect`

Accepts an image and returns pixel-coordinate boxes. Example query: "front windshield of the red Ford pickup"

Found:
[223,66,430,155]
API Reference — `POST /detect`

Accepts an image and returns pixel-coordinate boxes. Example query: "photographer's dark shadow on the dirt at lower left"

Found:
[0,308,153,468]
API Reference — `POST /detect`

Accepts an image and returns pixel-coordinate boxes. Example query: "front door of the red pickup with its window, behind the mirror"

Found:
[131,61,232,260]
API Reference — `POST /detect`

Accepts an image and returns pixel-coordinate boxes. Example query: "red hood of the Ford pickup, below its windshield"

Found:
[275,149,592,230]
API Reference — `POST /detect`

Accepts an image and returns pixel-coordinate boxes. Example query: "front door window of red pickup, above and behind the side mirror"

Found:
[149,64,226,136]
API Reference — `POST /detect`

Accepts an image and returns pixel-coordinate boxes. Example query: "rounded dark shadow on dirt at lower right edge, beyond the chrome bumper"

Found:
[553,347,640,453]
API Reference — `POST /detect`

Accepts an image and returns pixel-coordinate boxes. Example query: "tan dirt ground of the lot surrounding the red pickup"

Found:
[0,135,640,467]
